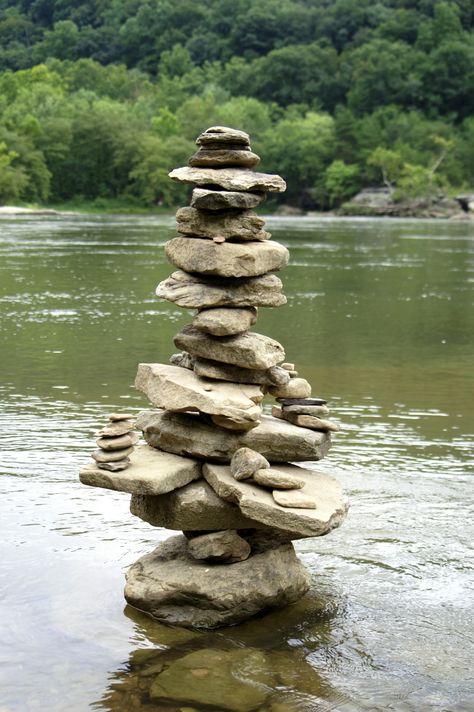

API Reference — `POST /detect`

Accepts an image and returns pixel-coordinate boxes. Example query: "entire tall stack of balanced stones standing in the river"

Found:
[80,126,347,628]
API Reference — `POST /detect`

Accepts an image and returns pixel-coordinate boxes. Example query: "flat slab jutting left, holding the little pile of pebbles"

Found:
[79,445,201,495]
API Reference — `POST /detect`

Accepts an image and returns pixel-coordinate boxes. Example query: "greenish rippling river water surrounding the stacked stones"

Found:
[0,217,474,712]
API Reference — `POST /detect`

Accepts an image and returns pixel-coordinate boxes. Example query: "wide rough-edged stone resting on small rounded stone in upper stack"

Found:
[156,270,286,309]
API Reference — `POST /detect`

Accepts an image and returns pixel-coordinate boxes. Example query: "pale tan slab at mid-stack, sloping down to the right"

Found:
[135,363,263,423]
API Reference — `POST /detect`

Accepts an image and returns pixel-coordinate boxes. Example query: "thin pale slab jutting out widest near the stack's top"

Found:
[168,166,286,193]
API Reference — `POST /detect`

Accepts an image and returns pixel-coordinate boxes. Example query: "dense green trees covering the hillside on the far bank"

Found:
[0,0,474,208]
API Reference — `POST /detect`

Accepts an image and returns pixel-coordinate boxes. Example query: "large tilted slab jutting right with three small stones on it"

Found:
[203,462,347,536]
